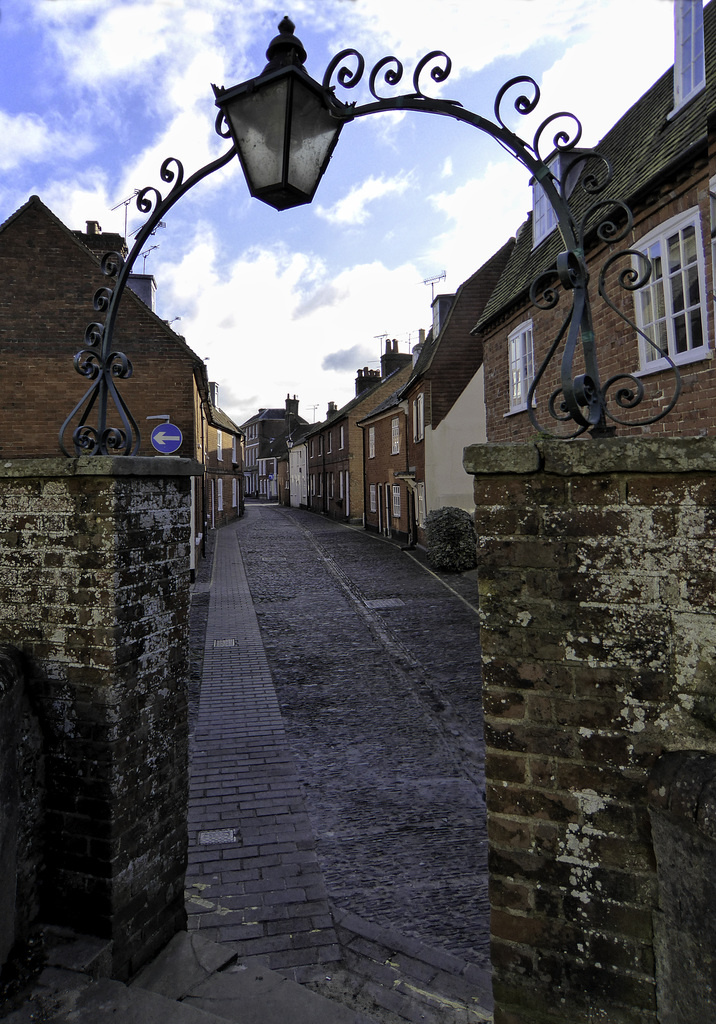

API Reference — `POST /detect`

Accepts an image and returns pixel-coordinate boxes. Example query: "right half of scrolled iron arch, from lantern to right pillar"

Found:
[324,49,680,438]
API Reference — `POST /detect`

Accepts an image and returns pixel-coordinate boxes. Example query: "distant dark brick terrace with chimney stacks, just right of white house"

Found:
[305,339,412,523]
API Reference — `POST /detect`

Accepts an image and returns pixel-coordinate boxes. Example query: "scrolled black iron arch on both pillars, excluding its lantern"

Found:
[60,26,680,455]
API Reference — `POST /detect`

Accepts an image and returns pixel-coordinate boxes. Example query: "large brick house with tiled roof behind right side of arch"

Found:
[475,3,716,441]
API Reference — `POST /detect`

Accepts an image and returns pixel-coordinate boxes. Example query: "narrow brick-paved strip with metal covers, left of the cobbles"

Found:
[186,528,340,967]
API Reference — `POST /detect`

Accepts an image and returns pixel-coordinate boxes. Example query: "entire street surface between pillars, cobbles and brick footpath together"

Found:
[187,503,491,1022]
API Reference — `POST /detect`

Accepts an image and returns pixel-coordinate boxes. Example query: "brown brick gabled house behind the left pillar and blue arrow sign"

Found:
[0,196,241,568]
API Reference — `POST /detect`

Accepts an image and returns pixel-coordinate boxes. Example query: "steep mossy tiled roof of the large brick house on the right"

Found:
[476,0,716,331]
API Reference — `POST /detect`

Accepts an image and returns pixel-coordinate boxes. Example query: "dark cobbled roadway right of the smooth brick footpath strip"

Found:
[236,503,489,966]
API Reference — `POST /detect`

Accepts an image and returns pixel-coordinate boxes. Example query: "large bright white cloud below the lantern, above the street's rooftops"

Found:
[157,228,429,423]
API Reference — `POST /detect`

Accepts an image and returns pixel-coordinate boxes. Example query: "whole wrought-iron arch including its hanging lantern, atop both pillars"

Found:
[59,17,680,455]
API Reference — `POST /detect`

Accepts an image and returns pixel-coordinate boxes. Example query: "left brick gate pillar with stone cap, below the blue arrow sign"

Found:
[0,458,200,979]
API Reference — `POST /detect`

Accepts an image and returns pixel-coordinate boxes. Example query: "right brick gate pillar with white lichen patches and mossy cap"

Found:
[464,437,716,1024]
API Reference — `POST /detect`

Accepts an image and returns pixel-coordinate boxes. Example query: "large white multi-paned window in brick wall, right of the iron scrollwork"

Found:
[634,208,708,371]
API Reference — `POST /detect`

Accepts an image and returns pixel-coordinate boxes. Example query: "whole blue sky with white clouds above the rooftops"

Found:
[0,0,674,424]
